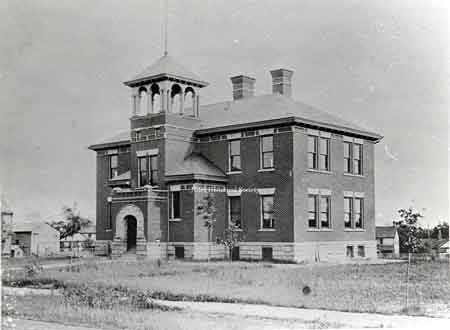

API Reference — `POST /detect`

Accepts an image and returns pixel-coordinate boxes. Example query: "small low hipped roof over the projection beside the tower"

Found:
[166,153,227,181]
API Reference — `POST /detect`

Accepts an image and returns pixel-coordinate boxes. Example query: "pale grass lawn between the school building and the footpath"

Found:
[5,261,450,315]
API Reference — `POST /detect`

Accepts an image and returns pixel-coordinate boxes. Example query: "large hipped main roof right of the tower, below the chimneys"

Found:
[199,94,382,140]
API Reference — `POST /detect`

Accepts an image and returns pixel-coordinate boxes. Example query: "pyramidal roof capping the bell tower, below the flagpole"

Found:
[125,55,208,87]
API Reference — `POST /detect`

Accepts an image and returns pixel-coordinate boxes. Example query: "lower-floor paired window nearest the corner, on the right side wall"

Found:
[308,194,331,229]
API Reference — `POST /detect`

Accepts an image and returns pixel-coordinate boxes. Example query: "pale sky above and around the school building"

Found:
[0,0,450,225]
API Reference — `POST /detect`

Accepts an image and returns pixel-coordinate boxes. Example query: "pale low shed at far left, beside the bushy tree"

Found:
[11,222,59,257]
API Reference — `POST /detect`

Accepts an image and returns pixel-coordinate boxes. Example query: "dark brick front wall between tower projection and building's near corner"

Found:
[197,132,294,242]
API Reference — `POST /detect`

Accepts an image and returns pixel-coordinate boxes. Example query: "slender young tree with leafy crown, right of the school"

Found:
[394,207,423,311]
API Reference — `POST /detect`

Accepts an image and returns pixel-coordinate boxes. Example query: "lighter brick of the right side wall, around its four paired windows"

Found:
[293,129,375,242]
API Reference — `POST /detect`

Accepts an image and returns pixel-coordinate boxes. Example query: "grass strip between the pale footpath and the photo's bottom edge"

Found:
[10,296,343,330]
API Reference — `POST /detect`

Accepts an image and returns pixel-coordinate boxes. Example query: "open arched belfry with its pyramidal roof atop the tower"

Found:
[124,54,208,118]
